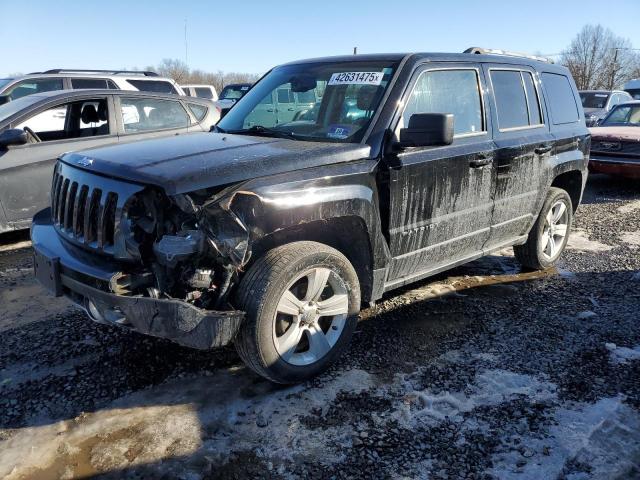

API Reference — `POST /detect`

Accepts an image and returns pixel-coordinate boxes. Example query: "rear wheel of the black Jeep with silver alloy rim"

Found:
[513,187,573,270]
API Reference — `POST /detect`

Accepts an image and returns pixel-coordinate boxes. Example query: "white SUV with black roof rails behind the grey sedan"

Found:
[0,68,184,104]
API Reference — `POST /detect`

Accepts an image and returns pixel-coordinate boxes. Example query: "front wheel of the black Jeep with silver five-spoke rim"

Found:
[235,242,360,384]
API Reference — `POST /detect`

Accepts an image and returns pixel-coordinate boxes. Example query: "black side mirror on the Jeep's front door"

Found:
[398,113,453,148]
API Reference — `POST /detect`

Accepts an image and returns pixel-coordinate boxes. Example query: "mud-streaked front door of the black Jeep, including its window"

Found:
[387,64,494,288]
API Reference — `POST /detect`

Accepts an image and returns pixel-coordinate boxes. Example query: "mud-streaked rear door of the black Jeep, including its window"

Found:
[484,64,554,250]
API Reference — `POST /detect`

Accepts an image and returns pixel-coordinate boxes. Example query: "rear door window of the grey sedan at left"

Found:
[120,98,189,133]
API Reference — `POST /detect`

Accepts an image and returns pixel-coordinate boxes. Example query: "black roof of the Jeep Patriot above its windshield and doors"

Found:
[285,52,564,69]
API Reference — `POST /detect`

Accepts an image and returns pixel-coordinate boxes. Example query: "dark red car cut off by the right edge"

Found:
[589,101,640,179]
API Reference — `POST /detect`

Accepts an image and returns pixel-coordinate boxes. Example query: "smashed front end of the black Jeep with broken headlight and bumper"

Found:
[32,166,255,349]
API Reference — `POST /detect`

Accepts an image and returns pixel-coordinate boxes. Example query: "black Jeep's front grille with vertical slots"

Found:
[51,162,143,256]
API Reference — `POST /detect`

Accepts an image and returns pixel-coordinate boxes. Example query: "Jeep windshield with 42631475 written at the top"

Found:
[218,60,396,143]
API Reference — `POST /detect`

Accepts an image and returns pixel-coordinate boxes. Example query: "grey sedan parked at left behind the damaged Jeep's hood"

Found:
[0,90,219,232]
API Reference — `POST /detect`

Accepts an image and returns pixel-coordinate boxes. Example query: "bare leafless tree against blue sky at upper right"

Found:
[561,25,640,90]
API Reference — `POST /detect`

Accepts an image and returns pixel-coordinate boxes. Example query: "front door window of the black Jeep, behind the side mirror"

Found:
[402,70,484,135]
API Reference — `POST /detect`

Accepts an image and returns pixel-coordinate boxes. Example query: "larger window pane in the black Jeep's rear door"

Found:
[491,70,529,130]
